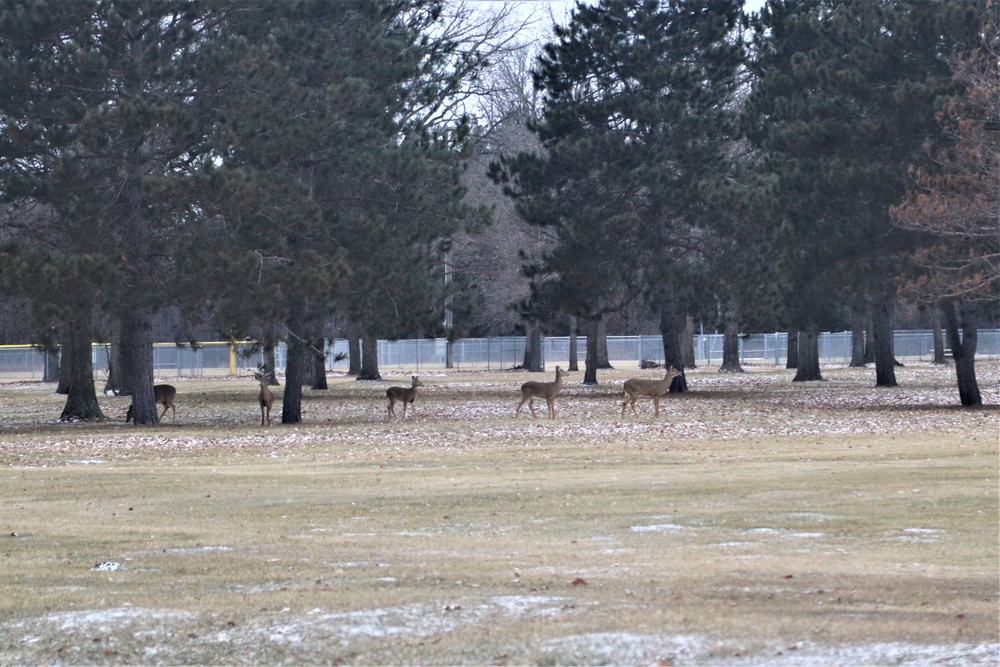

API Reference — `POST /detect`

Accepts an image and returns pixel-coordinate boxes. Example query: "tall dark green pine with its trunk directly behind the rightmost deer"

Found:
[493,0,742,383]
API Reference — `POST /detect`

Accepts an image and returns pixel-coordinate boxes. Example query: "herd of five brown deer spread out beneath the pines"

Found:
[125,366,681,426]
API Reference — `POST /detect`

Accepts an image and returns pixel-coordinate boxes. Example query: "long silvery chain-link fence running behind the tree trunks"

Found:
[0,329,1000,380]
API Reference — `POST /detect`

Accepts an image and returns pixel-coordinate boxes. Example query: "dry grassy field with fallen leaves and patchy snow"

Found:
[0,361,1000,665]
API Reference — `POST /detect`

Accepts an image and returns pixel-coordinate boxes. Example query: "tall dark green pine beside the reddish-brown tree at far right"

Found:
[744,0,981,386]
